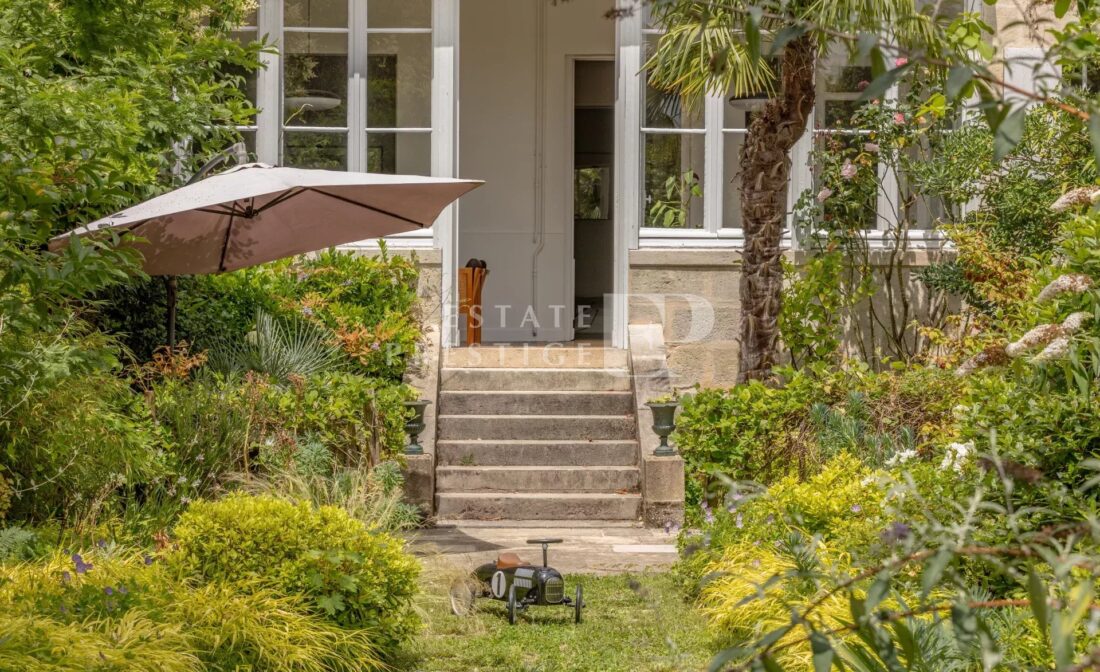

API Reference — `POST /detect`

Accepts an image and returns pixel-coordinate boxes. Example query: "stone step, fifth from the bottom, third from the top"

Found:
[439,390,634,416]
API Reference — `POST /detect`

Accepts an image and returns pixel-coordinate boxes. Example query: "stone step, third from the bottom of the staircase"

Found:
[436,440,638,466]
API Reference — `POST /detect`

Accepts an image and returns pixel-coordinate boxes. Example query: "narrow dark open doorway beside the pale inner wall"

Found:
[572,59,615,341]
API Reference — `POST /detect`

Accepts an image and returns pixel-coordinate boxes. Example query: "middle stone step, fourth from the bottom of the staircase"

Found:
[438,416,636,441]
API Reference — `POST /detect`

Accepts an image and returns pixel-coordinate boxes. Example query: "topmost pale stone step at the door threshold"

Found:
[443,343,628,370]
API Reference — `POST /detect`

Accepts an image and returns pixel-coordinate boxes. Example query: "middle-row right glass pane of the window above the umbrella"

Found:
[366,33,432,129]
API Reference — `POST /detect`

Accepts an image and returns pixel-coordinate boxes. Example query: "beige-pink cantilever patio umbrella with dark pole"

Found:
[50,164,482,344]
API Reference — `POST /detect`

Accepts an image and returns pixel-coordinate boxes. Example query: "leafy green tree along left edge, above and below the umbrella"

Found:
[0,0,260,521]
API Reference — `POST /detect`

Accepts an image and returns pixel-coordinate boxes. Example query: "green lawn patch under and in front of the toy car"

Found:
[397,569,714,672]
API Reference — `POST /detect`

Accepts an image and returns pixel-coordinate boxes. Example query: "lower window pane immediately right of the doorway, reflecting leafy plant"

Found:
[644,133,704,229]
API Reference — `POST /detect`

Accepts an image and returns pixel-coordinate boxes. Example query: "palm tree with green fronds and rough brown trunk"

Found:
[648,0,935,381]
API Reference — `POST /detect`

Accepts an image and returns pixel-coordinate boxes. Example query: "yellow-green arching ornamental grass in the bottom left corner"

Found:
[0,551,383,672]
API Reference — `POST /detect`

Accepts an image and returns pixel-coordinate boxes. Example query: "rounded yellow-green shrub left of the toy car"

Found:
[172,494,420,653]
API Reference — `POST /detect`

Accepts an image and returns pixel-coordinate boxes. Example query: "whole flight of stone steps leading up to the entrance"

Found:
[436,346,641,521]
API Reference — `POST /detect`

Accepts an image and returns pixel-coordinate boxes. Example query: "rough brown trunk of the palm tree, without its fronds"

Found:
[738,35,816,382]
